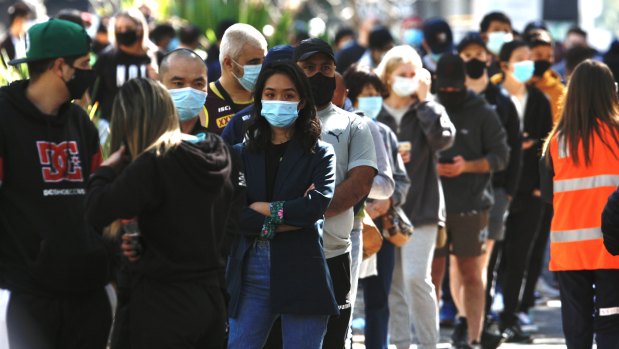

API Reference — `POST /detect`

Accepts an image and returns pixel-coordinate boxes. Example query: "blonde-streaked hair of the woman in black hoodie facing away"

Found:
[110,78,182,160]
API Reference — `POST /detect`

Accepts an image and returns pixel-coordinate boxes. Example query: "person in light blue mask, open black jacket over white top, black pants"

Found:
[491,40,552,342]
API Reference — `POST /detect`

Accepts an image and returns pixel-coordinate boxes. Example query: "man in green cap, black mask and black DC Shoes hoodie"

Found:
[0,19,112,349]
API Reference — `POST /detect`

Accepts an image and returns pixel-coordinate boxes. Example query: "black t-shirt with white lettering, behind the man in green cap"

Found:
[91,46,151,120]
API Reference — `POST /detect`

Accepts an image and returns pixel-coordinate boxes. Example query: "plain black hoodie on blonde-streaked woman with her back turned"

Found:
[86,134,234,286]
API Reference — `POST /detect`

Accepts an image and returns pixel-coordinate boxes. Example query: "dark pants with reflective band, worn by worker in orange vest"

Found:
[557,269,619,349]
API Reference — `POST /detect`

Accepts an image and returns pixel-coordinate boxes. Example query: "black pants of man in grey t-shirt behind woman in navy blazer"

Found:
[322,253,352,349]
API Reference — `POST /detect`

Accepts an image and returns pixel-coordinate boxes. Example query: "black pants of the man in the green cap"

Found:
[6,287,112,349]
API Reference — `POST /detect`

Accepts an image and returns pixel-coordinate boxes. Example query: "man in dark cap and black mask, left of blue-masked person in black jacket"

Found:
[458,33,522,348]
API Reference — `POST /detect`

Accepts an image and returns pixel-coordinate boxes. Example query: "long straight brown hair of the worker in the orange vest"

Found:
[544,59,619,166]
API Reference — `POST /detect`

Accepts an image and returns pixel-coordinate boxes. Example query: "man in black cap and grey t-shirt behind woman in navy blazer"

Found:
[294,39,377,348]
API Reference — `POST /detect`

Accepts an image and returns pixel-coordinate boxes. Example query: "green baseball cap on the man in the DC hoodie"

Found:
[9,19,90,65]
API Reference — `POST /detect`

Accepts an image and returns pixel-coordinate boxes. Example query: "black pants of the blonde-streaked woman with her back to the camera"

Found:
[111,278,227,349]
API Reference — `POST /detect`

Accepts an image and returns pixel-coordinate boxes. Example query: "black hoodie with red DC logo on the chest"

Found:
[0,81,110,295]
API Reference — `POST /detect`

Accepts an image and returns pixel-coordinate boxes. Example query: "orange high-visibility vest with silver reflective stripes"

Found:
[550,125,619,271]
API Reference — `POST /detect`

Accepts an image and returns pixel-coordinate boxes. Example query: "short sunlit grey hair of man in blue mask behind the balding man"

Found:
[219,23,267,66]
